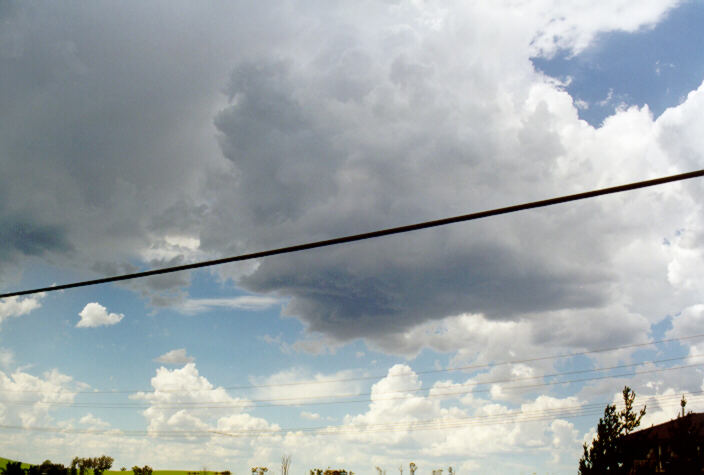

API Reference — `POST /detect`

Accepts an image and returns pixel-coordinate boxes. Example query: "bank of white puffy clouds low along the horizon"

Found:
[0,363,704,473]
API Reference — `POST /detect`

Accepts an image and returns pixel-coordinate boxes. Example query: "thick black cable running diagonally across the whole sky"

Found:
[0,169,704,298]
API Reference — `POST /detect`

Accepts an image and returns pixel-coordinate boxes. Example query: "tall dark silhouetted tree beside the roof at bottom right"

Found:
[579,386,645,475]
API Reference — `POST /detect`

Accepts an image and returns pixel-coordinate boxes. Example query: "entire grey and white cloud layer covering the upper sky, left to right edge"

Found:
[0,1,704,353]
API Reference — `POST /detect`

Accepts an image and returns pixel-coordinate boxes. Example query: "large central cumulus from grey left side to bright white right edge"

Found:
[201,4,704,351]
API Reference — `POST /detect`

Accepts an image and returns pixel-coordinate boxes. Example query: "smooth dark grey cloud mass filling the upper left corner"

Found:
[0,2,257,282]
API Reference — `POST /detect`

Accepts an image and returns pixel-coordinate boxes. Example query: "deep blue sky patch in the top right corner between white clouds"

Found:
[532,2,704,127]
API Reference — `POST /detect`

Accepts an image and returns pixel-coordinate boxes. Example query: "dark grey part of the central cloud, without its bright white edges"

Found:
[202,38,613,339]
